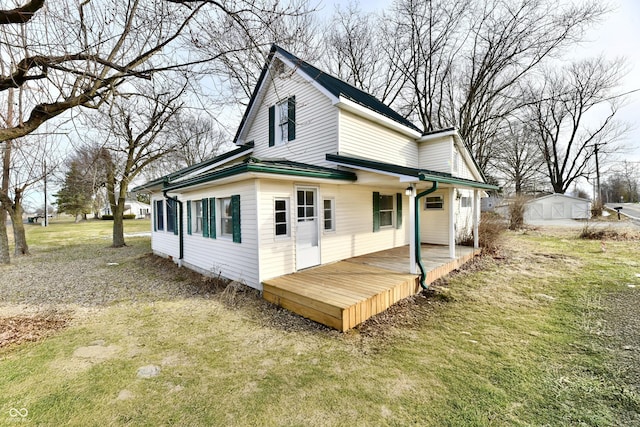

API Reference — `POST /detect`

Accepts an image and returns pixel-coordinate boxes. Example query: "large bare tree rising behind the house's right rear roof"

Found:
[384,0,606,170]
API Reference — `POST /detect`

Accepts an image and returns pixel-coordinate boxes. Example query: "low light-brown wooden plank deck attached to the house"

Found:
[263,245,478,331]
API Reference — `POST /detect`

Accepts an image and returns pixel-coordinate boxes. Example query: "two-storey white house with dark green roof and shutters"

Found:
[134,46,496,289]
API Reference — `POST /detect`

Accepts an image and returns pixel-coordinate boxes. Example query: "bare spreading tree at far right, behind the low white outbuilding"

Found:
[528,57,627,193]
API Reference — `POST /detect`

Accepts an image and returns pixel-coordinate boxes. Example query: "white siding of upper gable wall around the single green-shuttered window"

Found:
[246,73,338,166]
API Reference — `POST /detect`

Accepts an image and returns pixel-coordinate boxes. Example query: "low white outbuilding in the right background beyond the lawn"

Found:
[524,193,591,222]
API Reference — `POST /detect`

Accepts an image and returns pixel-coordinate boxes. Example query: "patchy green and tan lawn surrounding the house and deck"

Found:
[0,221,640,426]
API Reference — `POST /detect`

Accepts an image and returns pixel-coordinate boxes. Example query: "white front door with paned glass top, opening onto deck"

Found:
[296,187,320,270]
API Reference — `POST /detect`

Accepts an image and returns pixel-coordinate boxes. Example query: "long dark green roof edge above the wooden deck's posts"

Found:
[326,154,500,190]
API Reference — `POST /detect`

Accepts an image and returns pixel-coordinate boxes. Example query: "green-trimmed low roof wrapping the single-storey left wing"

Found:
[163,158,357,191]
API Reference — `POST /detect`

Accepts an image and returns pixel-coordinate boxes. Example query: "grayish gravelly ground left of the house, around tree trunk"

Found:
[0,239,210,307]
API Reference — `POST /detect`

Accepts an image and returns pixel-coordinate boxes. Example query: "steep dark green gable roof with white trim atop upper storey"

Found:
[233,44,422,143]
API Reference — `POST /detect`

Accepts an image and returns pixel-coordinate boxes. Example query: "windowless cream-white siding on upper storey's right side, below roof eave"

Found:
[339,110,418,168]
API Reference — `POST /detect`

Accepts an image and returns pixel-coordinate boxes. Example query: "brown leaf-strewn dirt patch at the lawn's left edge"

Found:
[0,313,71,348]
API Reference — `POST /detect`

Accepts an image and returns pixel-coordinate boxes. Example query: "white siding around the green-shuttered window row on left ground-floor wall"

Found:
[180,180,262,289]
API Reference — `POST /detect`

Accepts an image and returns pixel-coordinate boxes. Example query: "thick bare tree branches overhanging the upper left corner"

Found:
[0,0,208,142]
